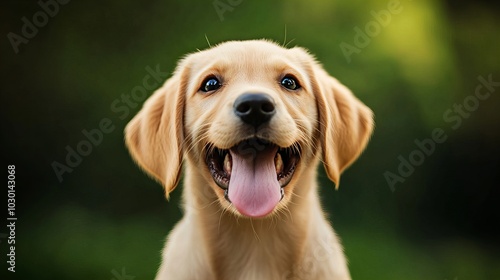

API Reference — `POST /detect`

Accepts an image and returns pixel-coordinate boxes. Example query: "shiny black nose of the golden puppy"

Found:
[234,93,276,127]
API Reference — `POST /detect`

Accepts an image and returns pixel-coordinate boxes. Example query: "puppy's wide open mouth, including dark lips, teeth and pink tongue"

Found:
[206,138,300,217]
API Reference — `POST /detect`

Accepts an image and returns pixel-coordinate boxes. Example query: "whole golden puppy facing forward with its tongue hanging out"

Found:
[125,40,373,280]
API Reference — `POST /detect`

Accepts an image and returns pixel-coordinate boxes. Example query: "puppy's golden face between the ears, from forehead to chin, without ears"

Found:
[184,42,318,217]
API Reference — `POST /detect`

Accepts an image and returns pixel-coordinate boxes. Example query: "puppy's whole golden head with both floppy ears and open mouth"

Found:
[126,40,373,218]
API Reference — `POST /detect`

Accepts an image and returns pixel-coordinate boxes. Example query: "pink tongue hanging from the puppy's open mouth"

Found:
[228,147,281,218]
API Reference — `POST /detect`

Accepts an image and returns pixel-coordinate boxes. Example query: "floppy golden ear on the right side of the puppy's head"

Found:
[313,65,373,188]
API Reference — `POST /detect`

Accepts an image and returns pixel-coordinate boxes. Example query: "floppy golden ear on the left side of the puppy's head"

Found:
[125,71,185,198]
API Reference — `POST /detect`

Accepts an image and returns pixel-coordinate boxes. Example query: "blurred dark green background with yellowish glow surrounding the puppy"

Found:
[0,0,500,280]
